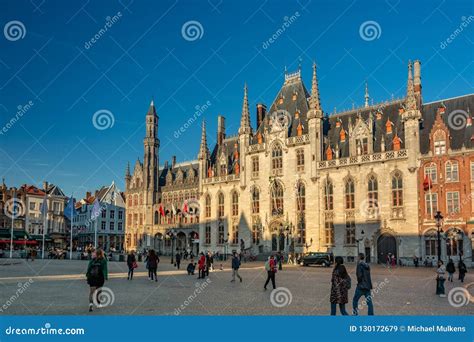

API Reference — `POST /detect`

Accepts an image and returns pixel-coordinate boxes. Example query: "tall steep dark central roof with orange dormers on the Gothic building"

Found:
[250,71,310,144]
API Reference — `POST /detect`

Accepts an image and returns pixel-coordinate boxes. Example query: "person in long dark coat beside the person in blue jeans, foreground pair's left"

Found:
[329,256,351,316]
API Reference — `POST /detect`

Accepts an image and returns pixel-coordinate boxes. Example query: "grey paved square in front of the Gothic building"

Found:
[0,257,474,315]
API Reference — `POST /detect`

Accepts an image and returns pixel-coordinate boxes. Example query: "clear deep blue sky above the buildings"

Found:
[0,0,474,196]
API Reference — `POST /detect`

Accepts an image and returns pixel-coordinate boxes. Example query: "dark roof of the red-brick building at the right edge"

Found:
[420,94,474,154]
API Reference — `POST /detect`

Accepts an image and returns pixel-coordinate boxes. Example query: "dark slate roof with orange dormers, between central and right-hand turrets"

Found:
[323,99,405,159]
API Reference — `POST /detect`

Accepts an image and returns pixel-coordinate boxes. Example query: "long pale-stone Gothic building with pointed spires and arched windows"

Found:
[126,61,472,261]
